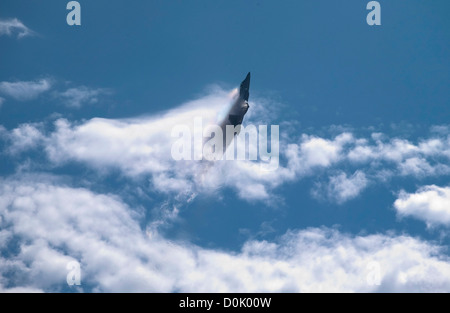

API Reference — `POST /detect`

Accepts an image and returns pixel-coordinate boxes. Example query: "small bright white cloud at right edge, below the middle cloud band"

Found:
[394,185,450,227]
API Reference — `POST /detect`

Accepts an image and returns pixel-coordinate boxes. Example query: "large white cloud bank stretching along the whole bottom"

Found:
[0,176,450,292]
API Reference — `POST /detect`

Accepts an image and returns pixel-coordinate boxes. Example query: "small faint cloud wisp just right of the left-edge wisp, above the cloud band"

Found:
[57,86,110,108]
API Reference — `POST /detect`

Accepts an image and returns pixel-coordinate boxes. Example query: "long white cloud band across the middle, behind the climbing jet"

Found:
[3,88,450,204]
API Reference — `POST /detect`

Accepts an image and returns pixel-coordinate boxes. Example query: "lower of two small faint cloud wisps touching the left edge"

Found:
[0,79,51,101]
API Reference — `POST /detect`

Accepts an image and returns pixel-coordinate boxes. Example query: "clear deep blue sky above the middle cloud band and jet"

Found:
[0,0,450,127]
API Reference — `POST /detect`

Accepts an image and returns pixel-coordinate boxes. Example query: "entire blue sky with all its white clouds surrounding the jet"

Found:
[0,0,450,292]
